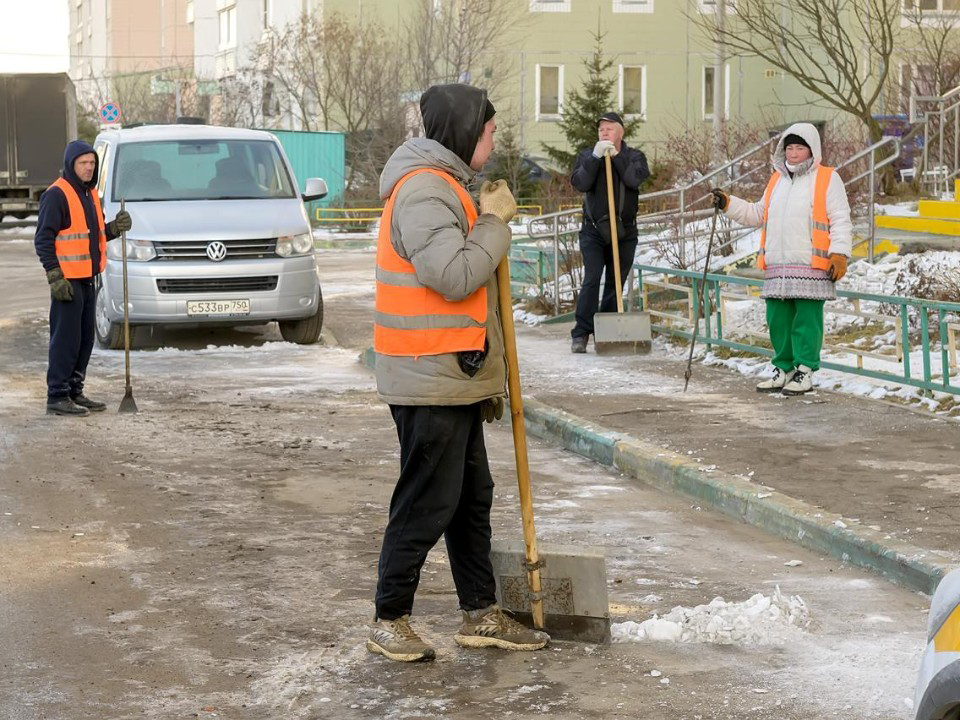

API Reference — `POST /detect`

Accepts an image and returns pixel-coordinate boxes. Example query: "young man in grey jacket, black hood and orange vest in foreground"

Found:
[367,84,549,662]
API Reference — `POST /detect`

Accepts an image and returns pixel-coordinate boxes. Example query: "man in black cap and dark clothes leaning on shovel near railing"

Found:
[570,112,650,353]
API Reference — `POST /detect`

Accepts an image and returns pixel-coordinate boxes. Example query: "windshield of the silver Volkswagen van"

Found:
[111,140,296,202]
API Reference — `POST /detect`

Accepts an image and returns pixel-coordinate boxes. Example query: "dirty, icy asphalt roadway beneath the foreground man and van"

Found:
[0,240,929,720]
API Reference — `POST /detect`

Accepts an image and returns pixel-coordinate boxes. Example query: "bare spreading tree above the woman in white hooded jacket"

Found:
[689,0,901,149]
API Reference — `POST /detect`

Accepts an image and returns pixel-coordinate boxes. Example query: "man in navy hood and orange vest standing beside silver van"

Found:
[33,140,132,415]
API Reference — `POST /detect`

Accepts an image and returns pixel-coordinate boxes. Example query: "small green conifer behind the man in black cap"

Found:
[542,32,638,172]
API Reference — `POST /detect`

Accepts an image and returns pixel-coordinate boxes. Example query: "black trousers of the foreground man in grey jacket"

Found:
[376,404,496,620]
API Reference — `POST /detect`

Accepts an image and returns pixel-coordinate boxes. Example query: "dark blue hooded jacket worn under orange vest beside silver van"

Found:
[33,140,116,275]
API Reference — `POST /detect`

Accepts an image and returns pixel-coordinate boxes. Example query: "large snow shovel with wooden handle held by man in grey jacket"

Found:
[490,258,610,643]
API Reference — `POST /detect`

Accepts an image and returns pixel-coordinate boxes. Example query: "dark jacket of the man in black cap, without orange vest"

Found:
[570,142,650,239]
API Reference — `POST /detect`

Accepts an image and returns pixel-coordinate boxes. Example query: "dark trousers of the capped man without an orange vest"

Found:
[570,223,637,338]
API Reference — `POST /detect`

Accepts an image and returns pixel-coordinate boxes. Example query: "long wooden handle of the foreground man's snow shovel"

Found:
[497,257,544,628]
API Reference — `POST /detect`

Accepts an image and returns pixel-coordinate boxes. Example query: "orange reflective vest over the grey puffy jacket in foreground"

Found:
[373,168,487,358]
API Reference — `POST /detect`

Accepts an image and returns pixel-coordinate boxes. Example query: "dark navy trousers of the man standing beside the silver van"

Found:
[47,278,96,401]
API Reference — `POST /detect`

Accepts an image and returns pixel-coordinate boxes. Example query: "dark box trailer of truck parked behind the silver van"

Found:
[0,73,77,220]
